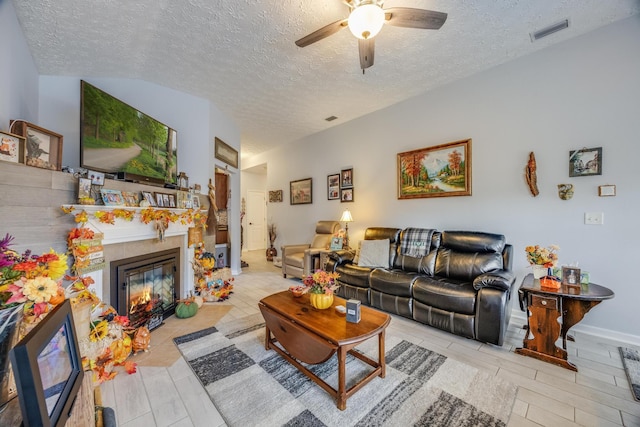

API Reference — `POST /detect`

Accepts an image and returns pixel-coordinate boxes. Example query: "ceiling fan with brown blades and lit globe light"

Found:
[296,0,447,74]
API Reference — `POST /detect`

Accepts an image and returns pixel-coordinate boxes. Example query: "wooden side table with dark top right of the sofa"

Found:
[516,274,614,371]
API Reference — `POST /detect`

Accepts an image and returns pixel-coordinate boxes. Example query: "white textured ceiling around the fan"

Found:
[10,0,640,157]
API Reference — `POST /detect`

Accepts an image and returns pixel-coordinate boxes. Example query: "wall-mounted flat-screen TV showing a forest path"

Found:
[81,82,177,183]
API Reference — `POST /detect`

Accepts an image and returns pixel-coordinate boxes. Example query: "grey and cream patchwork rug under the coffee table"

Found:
[174,314,516,427]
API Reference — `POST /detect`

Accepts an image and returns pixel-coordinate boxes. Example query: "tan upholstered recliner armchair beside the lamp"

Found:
[281,221,340,278]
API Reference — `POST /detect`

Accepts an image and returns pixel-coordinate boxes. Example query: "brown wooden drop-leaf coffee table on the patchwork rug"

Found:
[258,291,391,410]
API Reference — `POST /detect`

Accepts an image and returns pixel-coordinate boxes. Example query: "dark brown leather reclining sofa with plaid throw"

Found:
[325,227,516,345]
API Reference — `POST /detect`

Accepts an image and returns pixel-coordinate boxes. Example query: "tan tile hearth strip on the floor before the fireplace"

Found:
[129,303,233,367]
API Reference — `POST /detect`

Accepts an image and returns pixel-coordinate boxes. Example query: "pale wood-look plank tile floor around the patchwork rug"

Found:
[101,251,640,427]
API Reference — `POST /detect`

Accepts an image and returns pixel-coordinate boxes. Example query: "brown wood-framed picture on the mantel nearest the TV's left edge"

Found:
[9,120,63,171]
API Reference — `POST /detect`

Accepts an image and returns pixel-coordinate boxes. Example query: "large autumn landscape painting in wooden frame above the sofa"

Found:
[398,139,471,199]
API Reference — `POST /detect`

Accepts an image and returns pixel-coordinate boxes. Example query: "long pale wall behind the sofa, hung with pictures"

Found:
[245,16,640,341]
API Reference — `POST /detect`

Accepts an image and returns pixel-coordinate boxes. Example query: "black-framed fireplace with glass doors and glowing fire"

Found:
[110,248,180,330]
